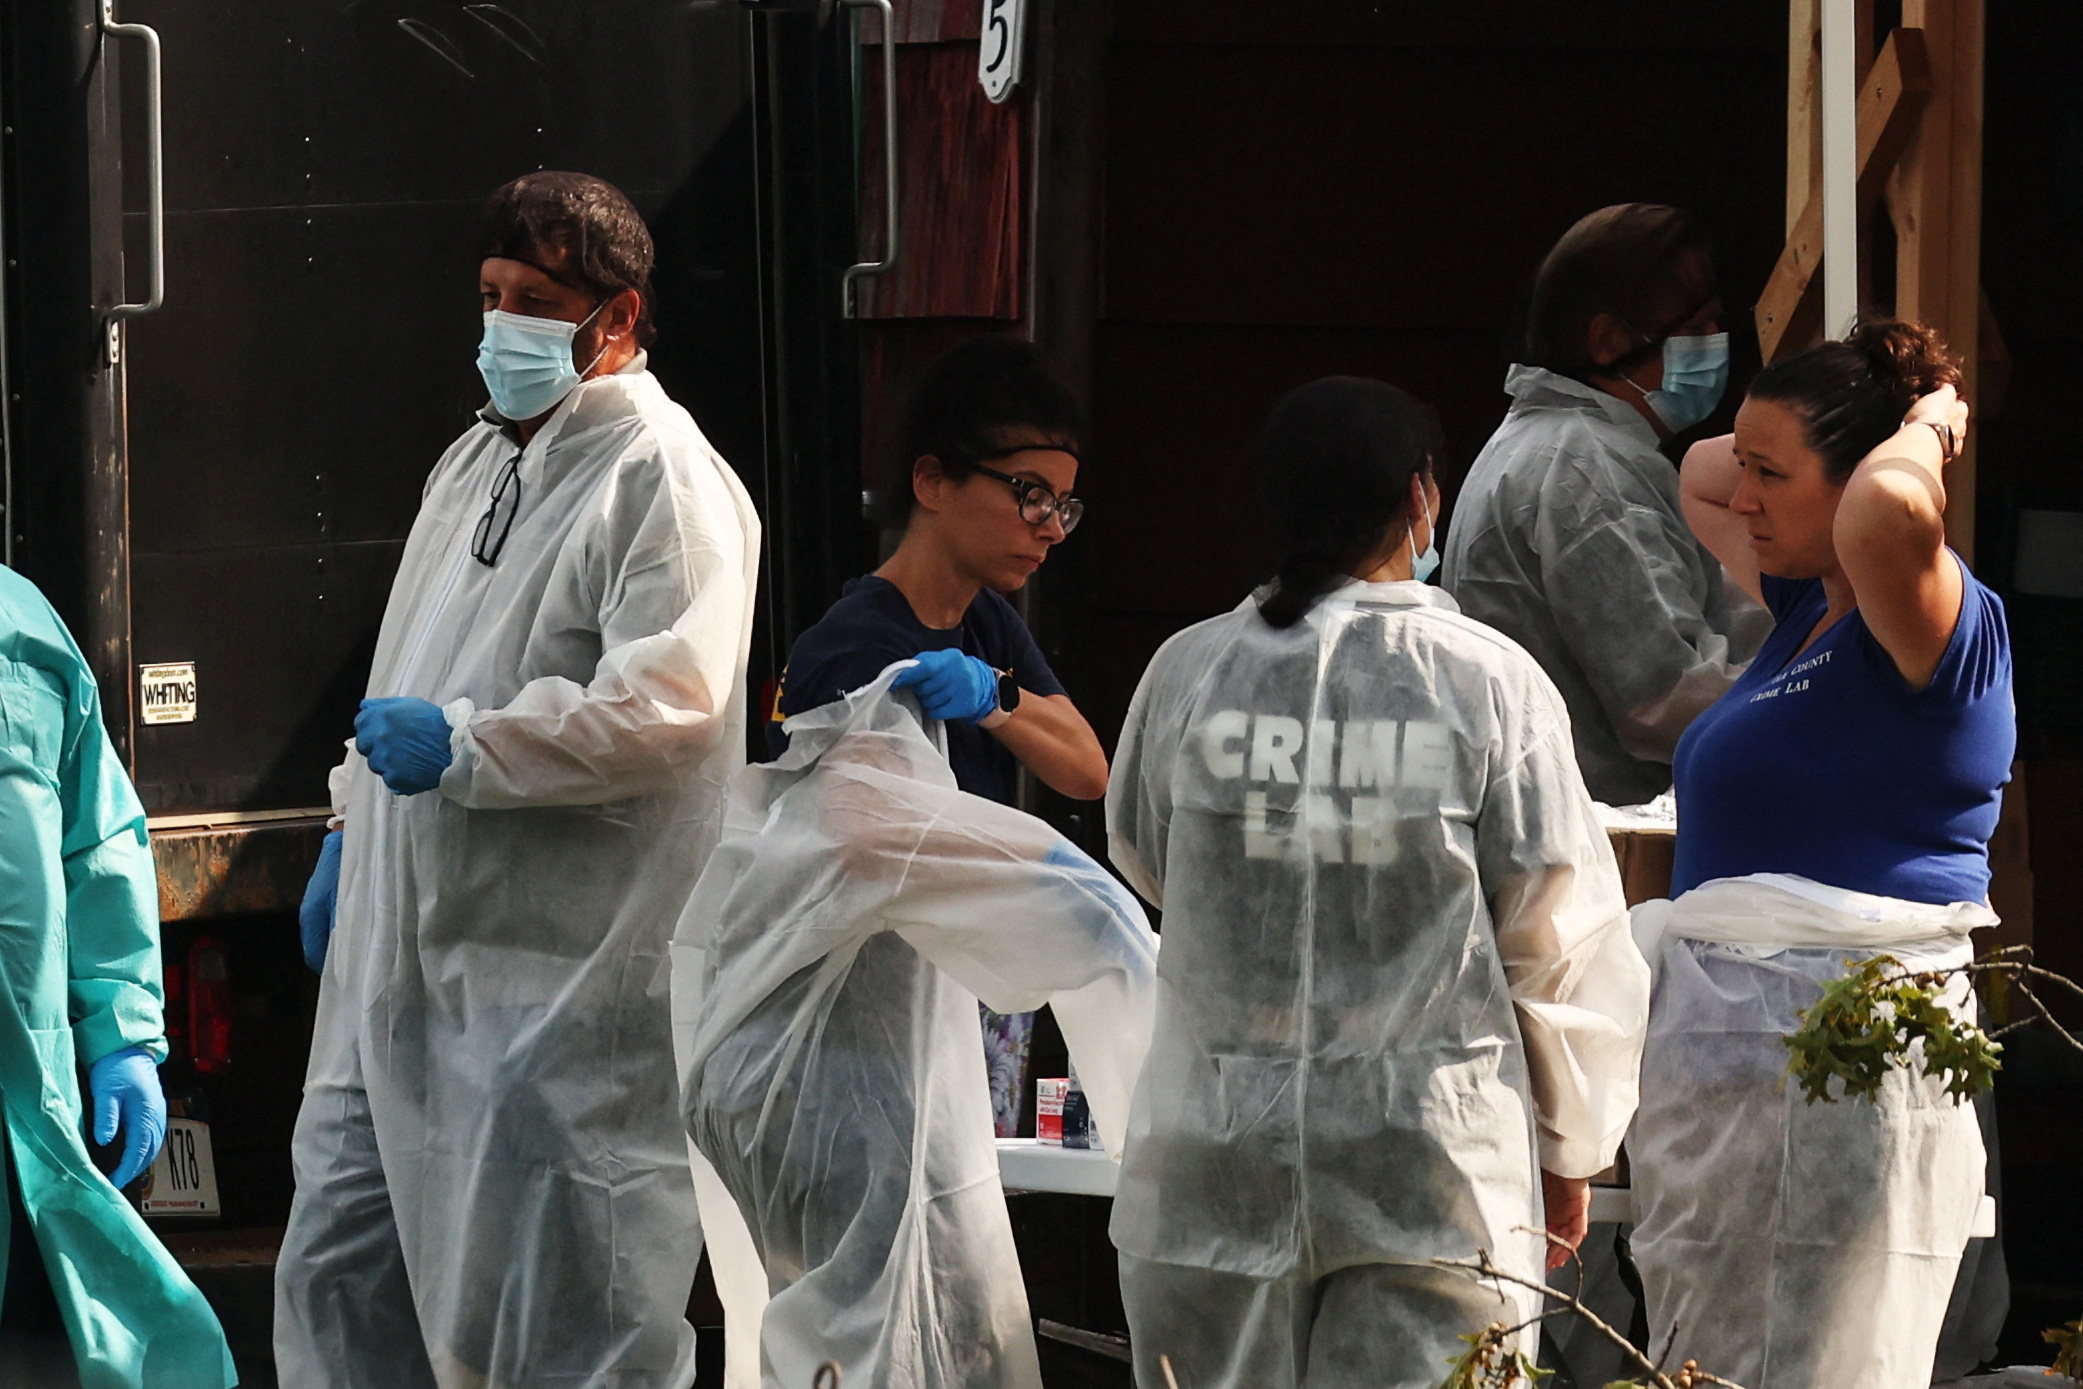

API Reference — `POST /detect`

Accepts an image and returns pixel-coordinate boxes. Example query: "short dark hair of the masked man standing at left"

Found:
[477,171,658,348]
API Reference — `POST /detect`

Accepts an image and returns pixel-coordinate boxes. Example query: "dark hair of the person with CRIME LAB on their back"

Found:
[1256,377,1444,627]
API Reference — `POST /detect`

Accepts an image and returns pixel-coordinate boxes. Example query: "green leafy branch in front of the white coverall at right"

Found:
[1785,945,2083,1104]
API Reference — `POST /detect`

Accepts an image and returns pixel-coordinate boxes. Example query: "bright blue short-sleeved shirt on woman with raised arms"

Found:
[1671,564,2018,904]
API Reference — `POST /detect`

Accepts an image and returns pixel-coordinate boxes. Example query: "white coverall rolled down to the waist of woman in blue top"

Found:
[1627,873,1996,1389]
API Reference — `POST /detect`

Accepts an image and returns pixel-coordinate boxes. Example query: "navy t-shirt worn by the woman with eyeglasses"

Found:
[767,575,1062,806]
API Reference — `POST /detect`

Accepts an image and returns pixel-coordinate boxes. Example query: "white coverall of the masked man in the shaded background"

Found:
[1439,367,1771,806]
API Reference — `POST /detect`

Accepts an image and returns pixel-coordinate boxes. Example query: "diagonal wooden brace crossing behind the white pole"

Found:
[1758,29,1931,362]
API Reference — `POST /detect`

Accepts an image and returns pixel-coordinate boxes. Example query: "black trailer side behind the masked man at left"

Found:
[0,0,862,1383]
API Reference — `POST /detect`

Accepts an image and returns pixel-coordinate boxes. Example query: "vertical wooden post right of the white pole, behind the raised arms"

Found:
[1887,0,1983,562]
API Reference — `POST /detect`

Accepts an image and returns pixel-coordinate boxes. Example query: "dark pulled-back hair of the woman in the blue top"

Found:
[1750,319,1962,483]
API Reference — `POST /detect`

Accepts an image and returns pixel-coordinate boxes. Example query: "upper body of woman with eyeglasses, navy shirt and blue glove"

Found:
[771,335,1106,806]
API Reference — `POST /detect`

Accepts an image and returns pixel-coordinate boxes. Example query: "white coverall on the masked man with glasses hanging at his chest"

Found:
[275,356,758,1389]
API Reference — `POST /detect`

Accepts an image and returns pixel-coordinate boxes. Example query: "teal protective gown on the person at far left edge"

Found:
[0,569,237,1389]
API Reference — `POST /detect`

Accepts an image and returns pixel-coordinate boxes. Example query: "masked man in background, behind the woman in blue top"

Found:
[1441,202,1768,806]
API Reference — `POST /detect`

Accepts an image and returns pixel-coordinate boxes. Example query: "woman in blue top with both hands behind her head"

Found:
[1629,323,2016,1389]
